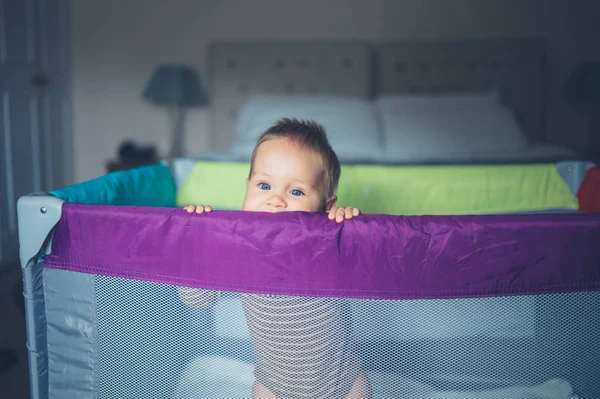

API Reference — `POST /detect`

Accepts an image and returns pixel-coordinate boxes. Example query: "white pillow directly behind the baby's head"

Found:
[231,95,383,162]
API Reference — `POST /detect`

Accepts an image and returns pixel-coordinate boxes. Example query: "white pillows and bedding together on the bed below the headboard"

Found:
[213,91,576,164]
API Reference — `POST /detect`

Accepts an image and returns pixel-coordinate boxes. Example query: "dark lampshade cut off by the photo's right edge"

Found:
[563,62,600,104]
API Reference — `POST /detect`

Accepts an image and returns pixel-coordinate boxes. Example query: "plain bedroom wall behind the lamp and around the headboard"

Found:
[73,0,600,181]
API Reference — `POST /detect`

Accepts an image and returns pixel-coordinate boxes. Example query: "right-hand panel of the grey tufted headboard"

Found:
[375,39,546,141]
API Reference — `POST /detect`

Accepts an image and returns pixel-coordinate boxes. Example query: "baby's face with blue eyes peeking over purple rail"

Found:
[242,138,333,213]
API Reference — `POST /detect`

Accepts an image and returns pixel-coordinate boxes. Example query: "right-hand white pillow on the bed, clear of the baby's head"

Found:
[381,106,527,162]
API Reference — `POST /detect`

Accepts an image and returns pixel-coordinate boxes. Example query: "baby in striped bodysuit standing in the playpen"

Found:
[178,119,371,399]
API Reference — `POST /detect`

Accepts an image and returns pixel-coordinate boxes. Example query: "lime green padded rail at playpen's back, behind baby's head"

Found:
[177,161,578,215]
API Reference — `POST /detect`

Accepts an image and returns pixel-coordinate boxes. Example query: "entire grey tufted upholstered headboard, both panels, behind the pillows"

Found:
[209,39,545,149]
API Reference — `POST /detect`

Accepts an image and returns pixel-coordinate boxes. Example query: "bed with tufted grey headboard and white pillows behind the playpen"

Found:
[200,39,582,164]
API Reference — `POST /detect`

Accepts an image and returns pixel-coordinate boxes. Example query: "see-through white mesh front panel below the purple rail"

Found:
[96,276,600,399]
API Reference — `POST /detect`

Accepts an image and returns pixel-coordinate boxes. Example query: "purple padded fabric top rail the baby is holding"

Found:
[44,203,600,299]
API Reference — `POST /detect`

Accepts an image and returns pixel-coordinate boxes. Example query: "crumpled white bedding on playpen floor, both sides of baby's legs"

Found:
[174,356,583,399]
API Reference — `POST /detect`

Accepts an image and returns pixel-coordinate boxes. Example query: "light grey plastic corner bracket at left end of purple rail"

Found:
[17,193,64,268]
